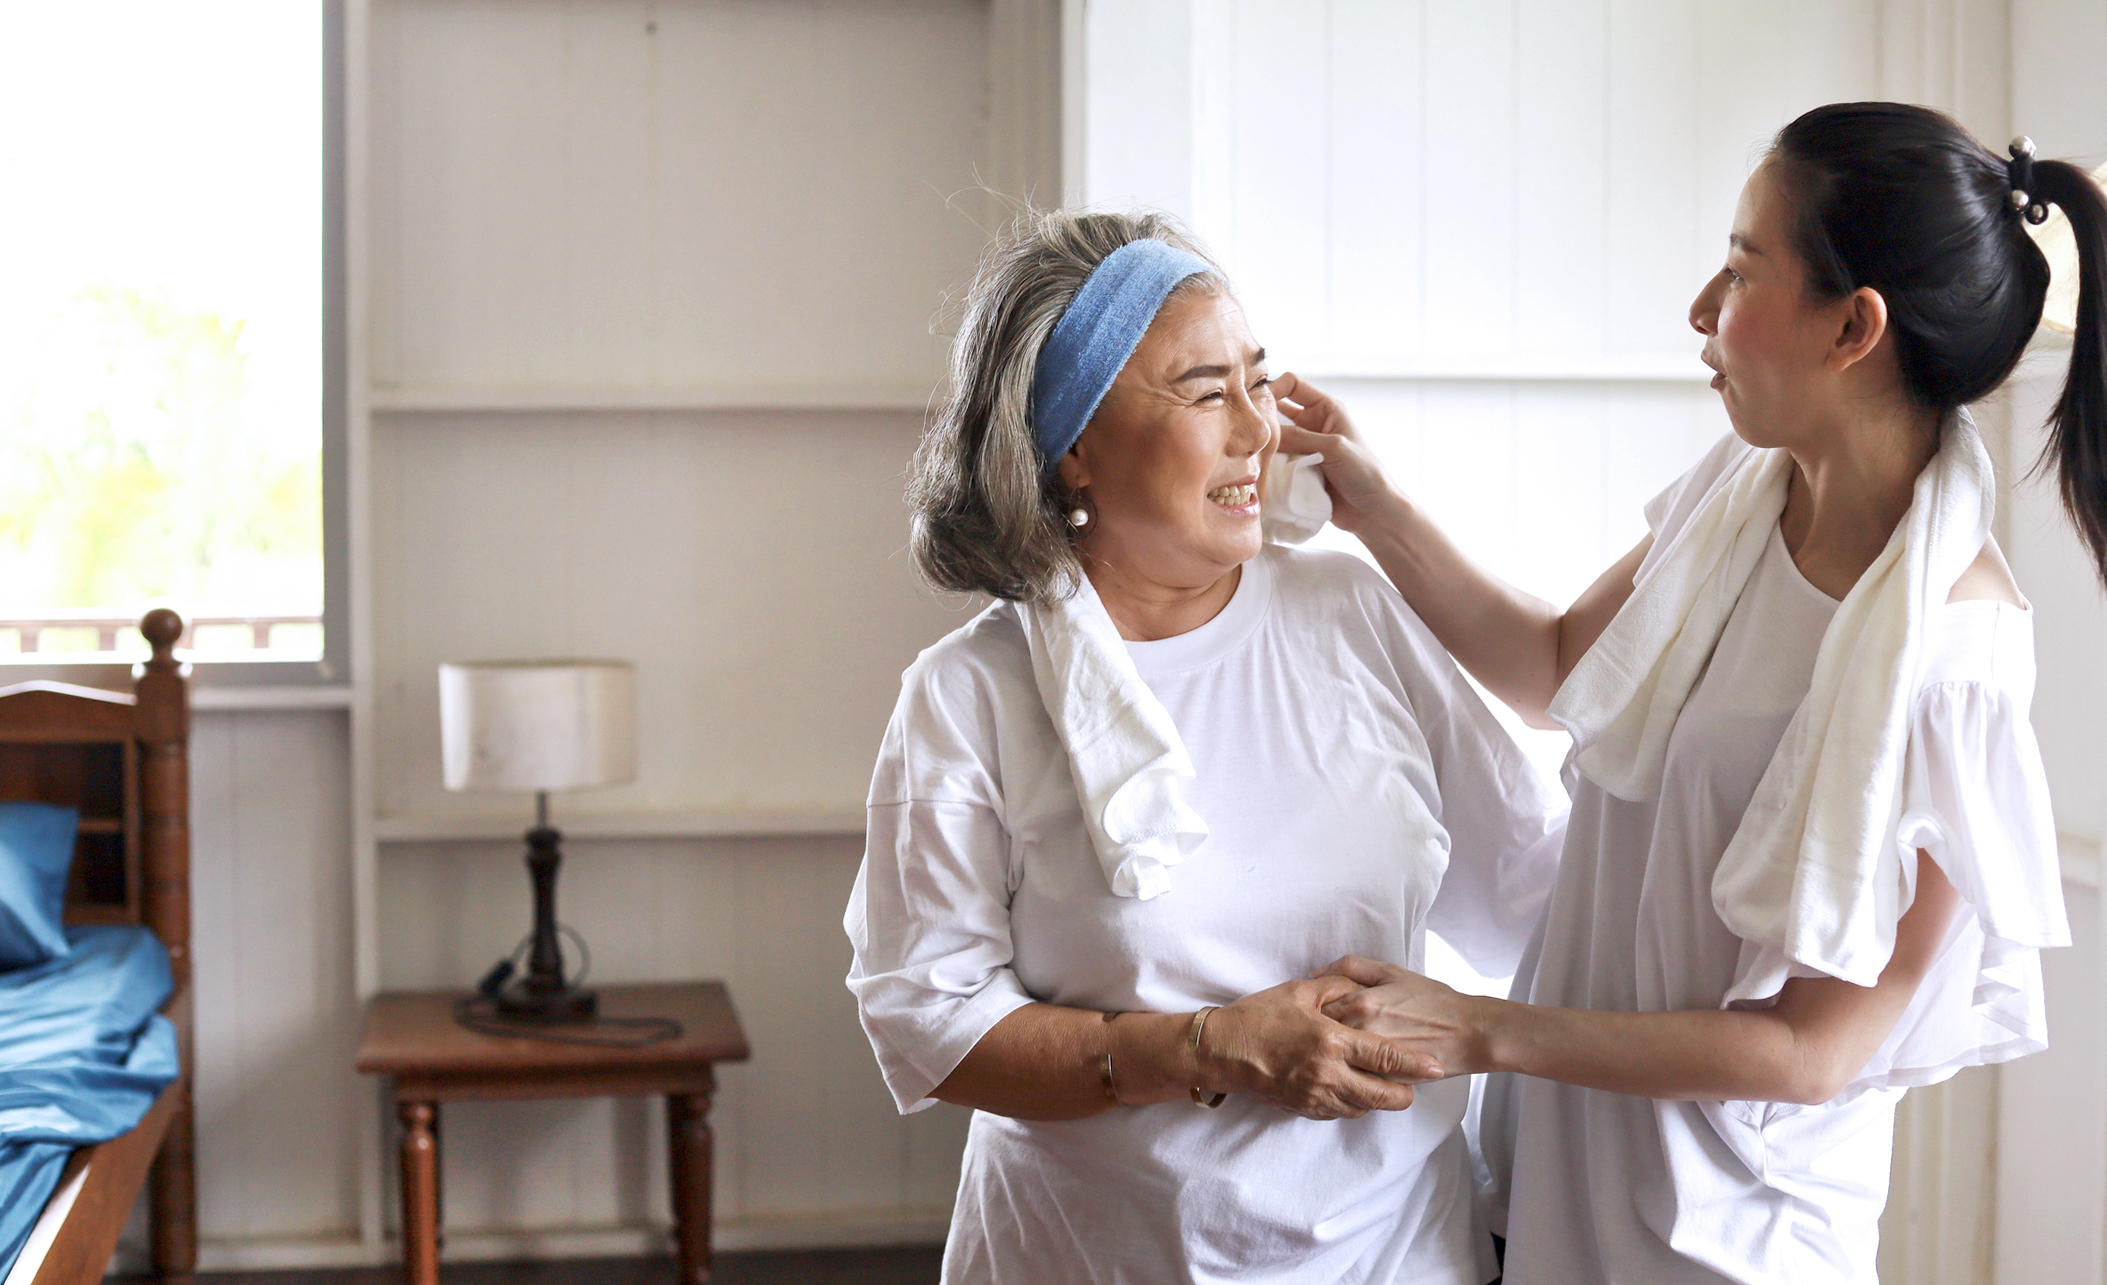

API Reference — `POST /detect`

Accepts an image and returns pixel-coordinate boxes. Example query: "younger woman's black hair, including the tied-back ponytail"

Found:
[1772,103,2107,584]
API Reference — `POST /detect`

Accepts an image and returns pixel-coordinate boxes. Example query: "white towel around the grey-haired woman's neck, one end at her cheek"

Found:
[1024,455,1332,902]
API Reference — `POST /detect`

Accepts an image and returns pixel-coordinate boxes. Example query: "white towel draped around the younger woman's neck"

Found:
[1551,411,1995,1003]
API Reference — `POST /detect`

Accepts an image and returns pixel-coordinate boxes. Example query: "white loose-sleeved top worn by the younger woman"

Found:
[1485,436,2069,1285]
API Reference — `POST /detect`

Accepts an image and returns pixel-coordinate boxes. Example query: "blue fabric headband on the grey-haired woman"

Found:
[1032,238,1214,472]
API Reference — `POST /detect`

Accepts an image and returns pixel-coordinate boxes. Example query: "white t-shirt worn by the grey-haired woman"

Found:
[845,548,1563,1285]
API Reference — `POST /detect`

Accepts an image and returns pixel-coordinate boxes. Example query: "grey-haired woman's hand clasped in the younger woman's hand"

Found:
[1199,977,1441,1121]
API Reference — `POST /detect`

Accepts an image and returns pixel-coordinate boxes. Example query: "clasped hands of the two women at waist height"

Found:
[1201,954,1483,1121]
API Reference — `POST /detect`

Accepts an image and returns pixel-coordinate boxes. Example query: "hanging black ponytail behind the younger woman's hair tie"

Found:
[2029,160,2107,581]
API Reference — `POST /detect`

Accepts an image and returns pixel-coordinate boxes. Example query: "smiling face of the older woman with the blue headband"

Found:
[1060,289,1279,590]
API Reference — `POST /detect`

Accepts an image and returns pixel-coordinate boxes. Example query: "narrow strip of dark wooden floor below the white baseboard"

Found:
[103,1245,944,1285]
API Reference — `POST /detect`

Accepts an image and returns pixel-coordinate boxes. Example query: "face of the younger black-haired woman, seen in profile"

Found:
[1690,160,1852,447]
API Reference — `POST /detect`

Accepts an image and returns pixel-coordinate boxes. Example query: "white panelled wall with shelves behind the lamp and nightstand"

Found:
[113,0,1060,1270]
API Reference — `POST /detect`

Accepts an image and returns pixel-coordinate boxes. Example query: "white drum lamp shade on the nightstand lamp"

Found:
[438,659,636,790]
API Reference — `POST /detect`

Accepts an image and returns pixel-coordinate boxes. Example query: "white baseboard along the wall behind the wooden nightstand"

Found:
[110,1209,950,1272]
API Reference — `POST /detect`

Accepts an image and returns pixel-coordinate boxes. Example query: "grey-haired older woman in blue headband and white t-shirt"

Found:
[845,213,1561,1285]
